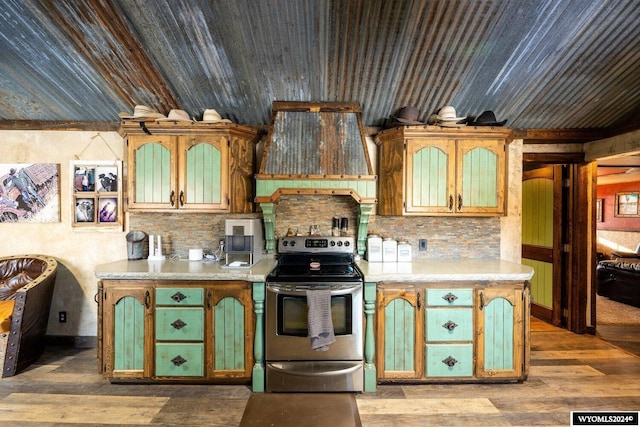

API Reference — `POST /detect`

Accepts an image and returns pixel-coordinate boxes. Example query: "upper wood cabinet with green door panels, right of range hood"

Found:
[377,126,509,216]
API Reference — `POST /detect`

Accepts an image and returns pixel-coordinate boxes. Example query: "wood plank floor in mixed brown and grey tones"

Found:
[0,319,640,427]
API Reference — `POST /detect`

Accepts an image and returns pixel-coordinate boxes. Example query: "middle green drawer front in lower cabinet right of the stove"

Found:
[424,308,473,341]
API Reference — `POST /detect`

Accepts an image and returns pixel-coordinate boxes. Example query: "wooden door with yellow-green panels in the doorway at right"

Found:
[522,166,563,326]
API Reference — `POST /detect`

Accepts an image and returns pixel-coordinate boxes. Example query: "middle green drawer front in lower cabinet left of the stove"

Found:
[156,307,204,341]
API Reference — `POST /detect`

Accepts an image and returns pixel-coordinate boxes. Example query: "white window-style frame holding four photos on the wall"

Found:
[70,160,124,231]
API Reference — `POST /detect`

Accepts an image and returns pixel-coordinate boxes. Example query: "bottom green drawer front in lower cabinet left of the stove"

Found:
[156,343,204,377]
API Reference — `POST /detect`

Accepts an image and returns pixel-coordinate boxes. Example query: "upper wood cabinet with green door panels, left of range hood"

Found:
[121,124,257,213]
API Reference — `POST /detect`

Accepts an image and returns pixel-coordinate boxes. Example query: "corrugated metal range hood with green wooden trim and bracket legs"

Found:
[255,101,377,255]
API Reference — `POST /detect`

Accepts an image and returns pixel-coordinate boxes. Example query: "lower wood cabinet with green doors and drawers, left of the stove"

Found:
[98,280,254,384]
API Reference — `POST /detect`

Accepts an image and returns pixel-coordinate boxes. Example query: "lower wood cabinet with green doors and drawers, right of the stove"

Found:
[375,282,530,382]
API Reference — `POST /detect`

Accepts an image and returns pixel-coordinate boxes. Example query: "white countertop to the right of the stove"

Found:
[358,258,533,282]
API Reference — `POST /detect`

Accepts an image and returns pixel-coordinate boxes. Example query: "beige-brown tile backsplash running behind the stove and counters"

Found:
[129,195,500,258]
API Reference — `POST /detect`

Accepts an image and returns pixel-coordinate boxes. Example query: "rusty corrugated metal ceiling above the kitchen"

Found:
[0,0,640,129]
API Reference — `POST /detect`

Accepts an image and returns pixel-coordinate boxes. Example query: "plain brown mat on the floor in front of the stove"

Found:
[240,393,362,427]
